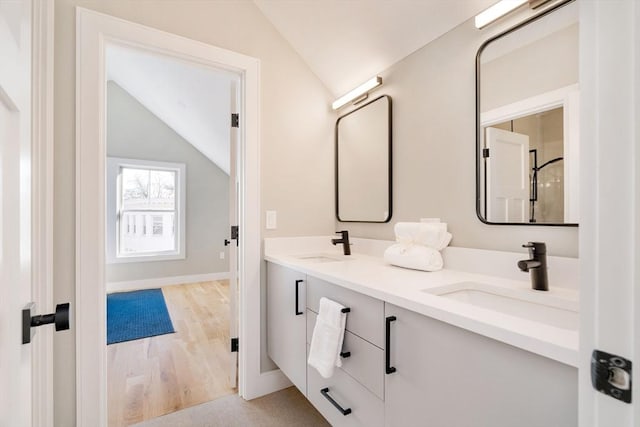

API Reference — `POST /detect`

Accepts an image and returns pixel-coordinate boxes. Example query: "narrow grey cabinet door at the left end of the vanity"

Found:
[267,263,307,396]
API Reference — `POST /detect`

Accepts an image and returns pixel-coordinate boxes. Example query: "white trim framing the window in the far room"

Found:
[105,157,187,264]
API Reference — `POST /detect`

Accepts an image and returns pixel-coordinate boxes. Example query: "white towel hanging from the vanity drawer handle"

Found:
[308,297,347,378]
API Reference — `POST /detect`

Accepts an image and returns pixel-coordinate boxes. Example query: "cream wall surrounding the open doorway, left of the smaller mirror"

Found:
[54,0,335,427]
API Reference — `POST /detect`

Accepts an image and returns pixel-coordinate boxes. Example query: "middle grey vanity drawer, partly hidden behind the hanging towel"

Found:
[307,310,384,399]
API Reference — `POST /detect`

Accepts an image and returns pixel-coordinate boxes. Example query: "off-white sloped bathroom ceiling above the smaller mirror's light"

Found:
[254,0,497,97]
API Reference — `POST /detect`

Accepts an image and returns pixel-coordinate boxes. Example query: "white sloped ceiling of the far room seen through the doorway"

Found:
[107,45,236,174]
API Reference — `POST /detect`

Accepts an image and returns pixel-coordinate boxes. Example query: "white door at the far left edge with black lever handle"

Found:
[0,1,32,426]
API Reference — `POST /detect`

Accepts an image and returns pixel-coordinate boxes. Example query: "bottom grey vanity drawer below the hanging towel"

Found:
[307,346,384,427]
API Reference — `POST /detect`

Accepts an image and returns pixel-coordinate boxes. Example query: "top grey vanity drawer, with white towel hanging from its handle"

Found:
[307,276,384,348]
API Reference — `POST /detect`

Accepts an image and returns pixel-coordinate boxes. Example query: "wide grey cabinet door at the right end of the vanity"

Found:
[385,304,578,427]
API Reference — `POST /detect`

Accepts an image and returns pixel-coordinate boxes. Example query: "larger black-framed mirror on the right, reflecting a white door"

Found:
[476,1,580,226]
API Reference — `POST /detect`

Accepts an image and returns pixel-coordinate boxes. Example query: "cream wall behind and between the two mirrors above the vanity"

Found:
[336,8,578,260]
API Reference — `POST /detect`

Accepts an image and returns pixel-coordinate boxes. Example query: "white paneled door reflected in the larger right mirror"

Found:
[485,127,530,222]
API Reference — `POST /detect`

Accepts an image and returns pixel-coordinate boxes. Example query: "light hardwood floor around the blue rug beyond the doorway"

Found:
[107,281,236,427]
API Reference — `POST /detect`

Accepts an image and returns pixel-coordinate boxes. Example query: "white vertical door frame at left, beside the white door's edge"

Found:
[31,0,55,427]
